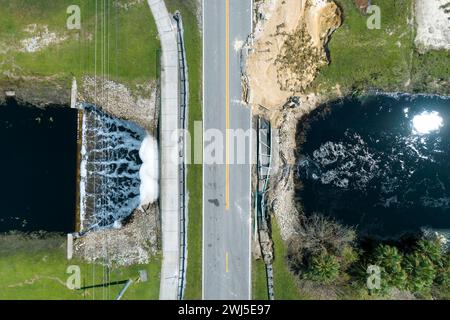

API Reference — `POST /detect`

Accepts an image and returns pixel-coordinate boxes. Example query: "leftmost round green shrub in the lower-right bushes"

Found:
[305,253,340,284]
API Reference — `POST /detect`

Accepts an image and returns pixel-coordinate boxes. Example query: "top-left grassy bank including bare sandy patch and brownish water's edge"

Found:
[0,0,160,104]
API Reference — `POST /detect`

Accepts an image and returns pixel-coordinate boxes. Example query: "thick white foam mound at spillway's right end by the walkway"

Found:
[139,135,159,206]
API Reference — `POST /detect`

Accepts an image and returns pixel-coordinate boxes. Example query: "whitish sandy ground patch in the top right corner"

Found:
[415,0,450,52]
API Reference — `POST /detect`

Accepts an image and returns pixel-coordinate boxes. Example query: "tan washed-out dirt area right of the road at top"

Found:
[247,0,341,109]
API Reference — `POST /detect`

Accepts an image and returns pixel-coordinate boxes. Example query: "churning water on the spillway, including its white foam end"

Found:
[80,104,159,232]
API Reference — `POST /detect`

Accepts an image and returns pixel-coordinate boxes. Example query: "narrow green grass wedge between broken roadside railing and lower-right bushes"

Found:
[272,220,310,300]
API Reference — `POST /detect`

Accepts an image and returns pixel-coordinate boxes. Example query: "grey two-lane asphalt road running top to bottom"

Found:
[203,0,252,300]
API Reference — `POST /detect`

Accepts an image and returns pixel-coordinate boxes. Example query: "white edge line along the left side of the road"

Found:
[202,0,206,300]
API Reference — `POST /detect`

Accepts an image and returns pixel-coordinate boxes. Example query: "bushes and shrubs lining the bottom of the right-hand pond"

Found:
[288,215,450,299]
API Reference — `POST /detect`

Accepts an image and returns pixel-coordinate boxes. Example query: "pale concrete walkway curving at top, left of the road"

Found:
[147,0,180,300]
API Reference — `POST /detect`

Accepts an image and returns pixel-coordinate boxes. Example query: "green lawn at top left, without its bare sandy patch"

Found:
[0,0,160,86]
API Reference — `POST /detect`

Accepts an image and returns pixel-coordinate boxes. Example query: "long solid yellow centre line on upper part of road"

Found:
[225,0,230,210]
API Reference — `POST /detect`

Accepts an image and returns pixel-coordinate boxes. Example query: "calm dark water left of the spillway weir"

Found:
[0,101,77,232]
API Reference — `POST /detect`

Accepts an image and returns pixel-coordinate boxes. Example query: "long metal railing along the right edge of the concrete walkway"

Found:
[173,11,189,300]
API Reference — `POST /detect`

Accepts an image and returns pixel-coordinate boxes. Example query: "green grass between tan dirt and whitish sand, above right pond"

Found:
[316,0,412,94]
